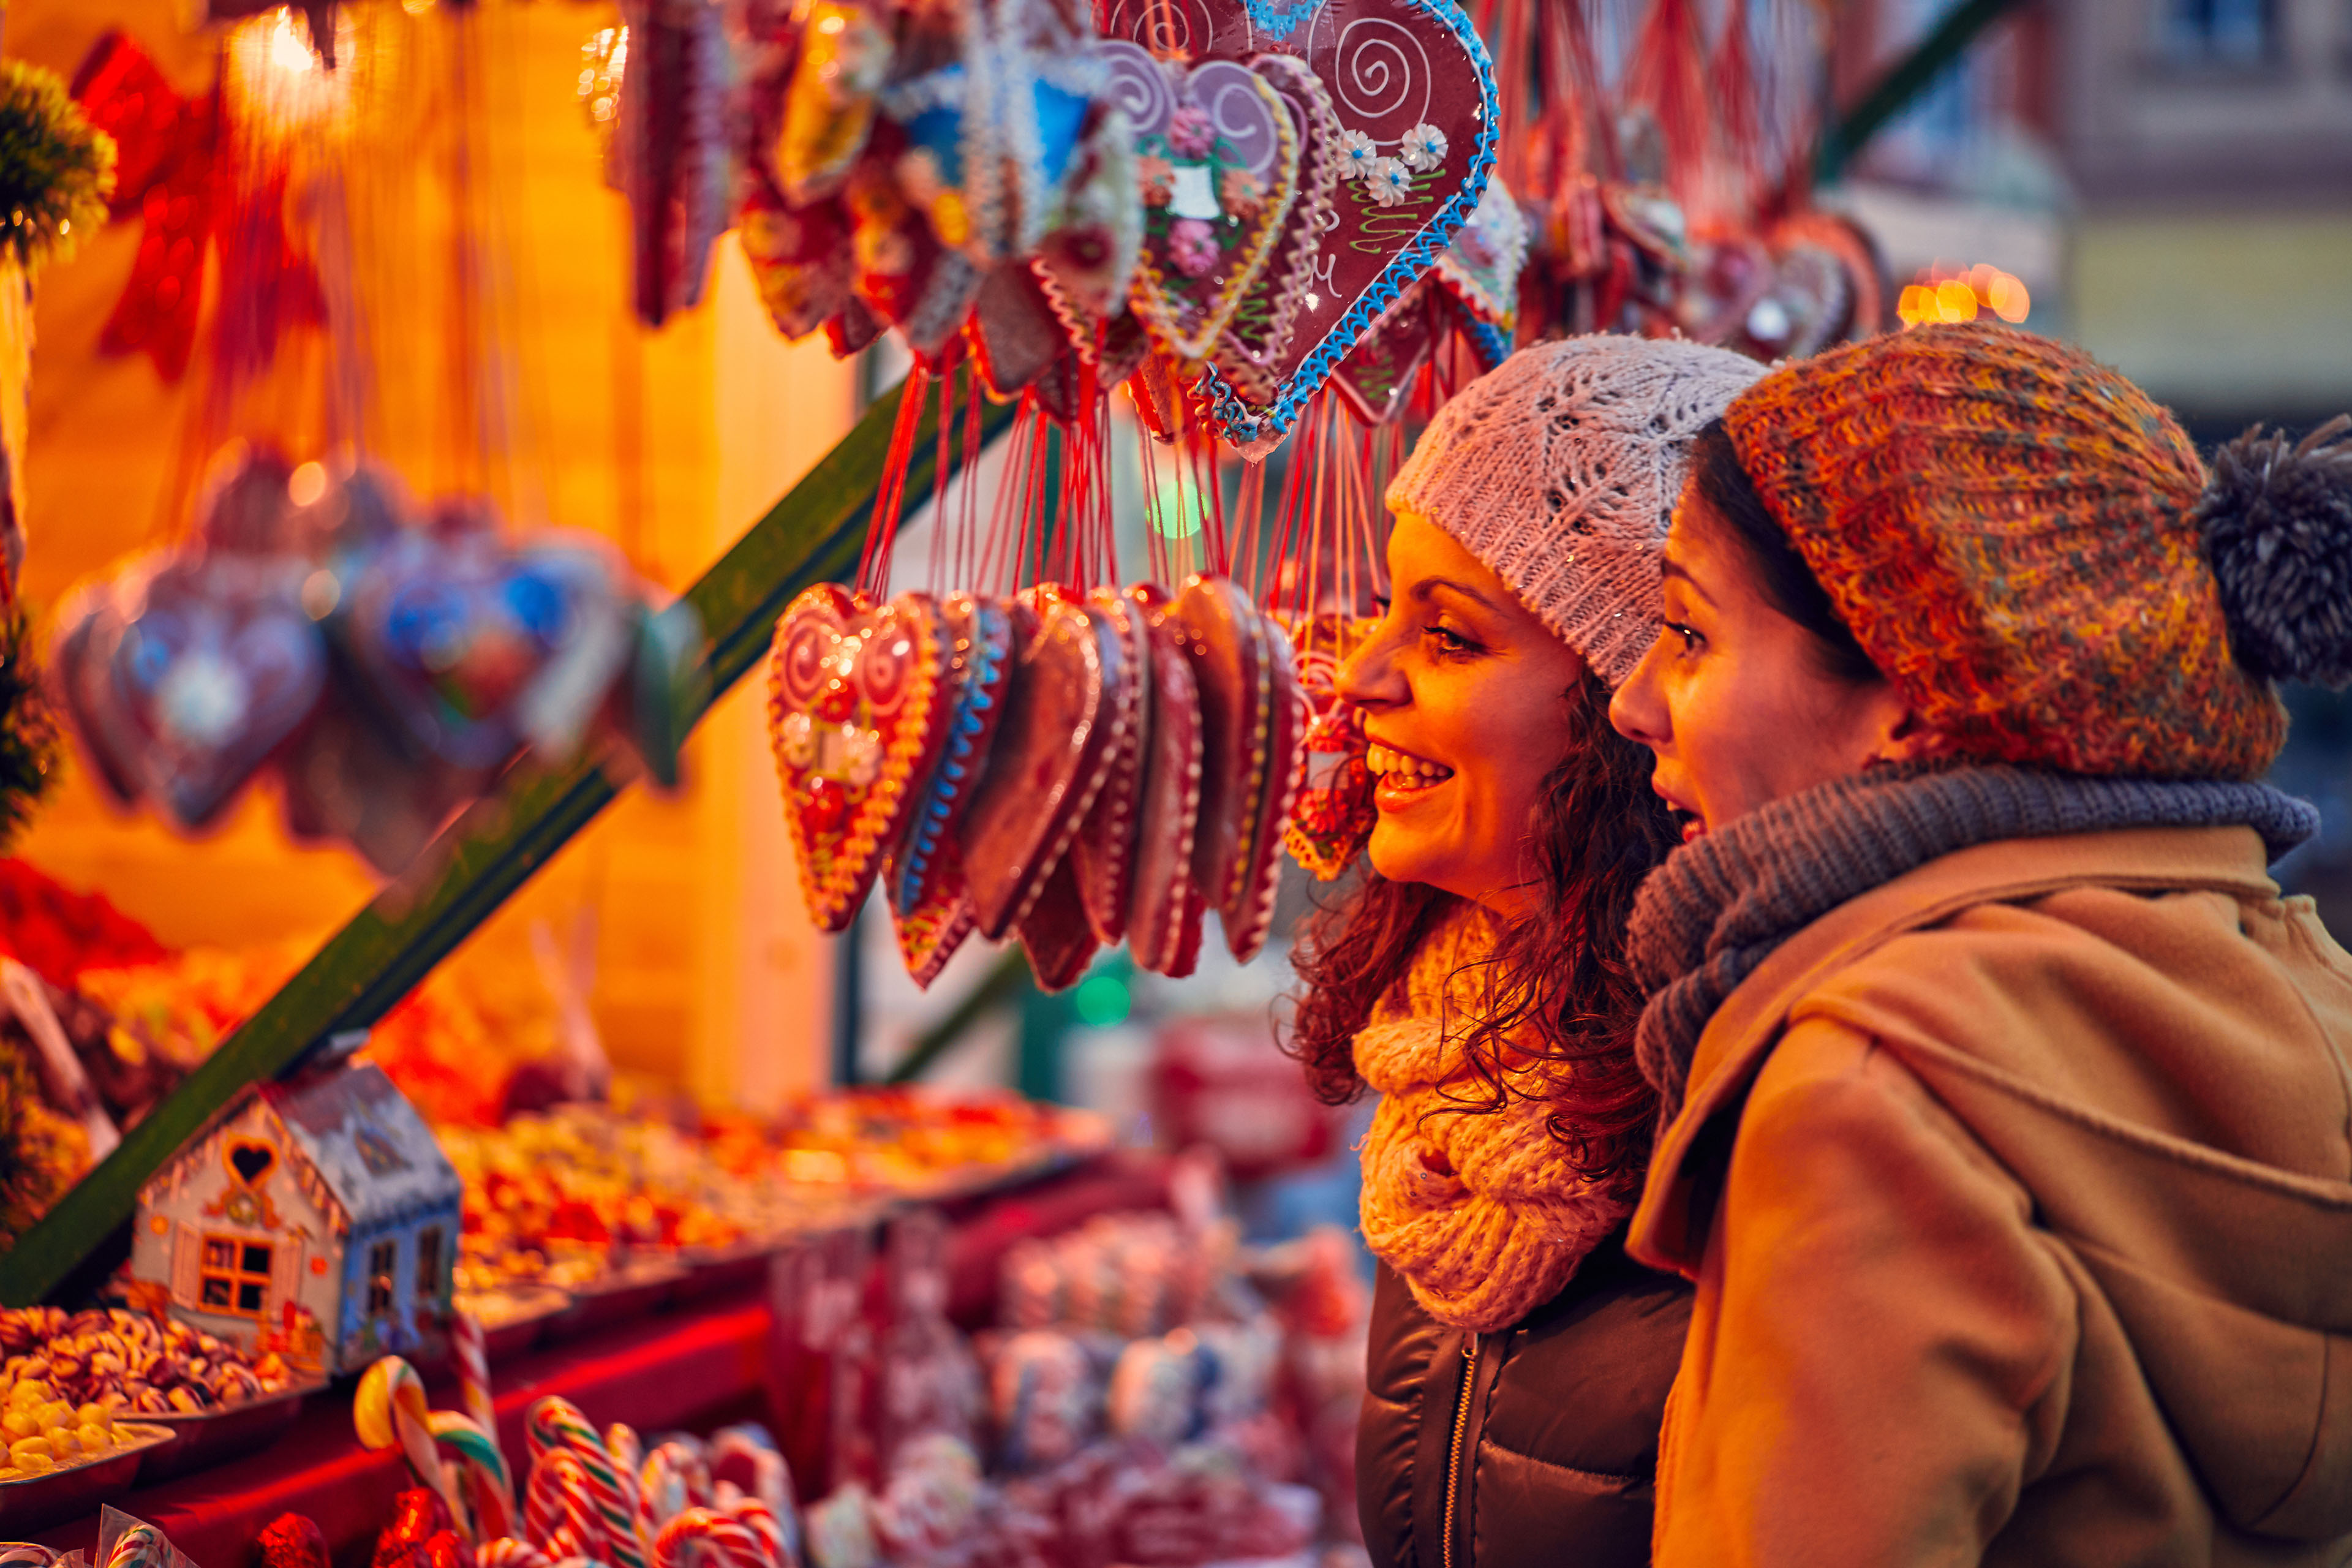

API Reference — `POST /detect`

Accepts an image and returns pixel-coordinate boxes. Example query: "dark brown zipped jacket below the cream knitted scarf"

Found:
[1355,1232,1691,1568]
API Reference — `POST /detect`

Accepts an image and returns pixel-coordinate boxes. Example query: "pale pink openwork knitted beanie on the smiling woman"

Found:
[1388,334,1764,687]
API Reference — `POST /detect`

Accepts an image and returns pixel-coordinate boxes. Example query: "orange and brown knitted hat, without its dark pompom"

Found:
[1724,325,2286,778]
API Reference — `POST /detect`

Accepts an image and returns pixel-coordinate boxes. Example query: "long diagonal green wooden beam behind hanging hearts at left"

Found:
[0,371,1014,1307]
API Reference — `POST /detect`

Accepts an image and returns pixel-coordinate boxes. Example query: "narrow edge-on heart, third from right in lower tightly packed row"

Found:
[1126,583,1207,978]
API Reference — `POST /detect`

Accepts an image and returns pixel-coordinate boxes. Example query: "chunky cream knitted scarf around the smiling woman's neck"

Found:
[1355,905,1635,1333]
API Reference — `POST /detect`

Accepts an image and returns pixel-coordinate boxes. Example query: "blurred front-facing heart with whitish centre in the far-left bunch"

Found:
[99,557,327,830]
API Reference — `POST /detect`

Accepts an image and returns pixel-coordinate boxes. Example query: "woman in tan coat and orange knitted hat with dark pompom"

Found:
[1613,326,2352,1568]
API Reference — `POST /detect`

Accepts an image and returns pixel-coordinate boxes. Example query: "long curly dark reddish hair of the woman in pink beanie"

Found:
[1289,673,1675,1183]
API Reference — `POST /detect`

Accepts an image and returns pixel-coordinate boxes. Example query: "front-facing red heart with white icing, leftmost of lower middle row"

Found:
[767,583,955,931]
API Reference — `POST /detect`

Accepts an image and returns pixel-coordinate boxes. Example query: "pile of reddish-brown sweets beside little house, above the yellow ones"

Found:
[0,1307,294,1415]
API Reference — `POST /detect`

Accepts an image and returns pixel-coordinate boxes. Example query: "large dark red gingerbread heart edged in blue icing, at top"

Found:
[1103,0,1496,449]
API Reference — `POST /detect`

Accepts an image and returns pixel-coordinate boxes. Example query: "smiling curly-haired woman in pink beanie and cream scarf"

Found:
[1291,336,1762,1568]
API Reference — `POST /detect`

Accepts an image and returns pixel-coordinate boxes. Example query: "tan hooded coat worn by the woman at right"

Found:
[1627,827,2352,1568]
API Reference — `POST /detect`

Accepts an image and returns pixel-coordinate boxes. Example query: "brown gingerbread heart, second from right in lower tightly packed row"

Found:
[1174,576,1272,944]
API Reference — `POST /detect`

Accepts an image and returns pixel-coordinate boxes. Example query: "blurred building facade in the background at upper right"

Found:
[1832,0,2352,440]
